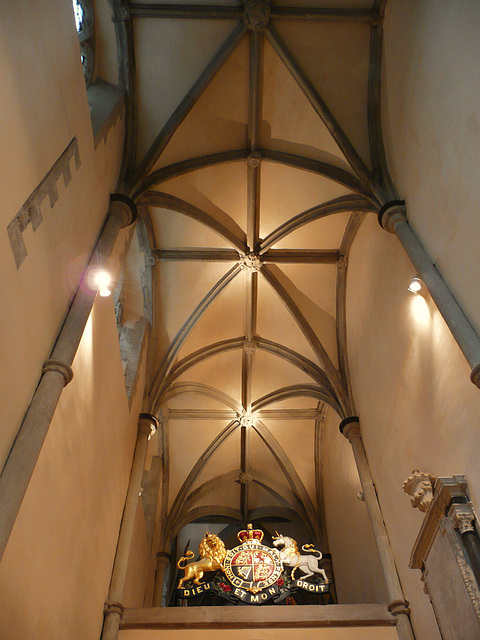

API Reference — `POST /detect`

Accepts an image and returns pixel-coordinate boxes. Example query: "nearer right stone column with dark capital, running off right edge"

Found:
[378,201,480,387]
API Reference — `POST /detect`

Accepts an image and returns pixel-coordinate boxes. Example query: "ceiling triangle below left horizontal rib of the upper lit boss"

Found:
[157,262,236,360]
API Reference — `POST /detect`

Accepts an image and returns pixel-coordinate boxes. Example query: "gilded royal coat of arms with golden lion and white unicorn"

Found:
[177,524,330,604]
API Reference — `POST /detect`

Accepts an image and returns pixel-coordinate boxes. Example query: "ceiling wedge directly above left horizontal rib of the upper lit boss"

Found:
[150,207,234,249]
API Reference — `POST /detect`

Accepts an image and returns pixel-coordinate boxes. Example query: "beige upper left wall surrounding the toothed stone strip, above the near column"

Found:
[0,0,123,468]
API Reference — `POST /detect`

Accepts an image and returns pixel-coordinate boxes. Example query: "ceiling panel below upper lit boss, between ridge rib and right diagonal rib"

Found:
[257,277,317,364]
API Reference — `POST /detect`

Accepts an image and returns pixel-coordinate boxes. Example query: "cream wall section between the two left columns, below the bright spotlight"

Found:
[0,298,143,640]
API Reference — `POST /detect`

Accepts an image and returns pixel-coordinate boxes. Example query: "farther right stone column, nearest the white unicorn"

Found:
[340,416,415,640]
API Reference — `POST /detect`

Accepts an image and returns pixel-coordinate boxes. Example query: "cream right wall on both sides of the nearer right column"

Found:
[347,0,480,639]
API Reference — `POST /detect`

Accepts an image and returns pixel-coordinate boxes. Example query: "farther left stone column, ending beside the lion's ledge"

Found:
[102,413,158,640]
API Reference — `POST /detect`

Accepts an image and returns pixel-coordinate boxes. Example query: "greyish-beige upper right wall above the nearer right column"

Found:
[382,0,480,332]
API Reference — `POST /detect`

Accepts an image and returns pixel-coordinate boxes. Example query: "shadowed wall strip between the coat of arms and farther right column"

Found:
[322,409,388,604]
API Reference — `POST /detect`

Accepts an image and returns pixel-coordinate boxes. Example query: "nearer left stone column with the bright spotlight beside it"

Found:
[0,194,137,560]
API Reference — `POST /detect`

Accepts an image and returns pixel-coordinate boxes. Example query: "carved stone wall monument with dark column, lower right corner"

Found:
[404,471,480,640]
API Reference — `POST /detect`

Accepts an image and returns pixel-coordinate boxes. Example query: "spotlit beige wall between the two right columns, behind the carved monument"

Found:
[347,216,480,639]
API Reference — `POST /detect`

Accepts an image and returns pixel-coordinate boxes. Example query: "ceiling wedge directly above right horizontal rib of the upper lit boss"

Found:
[274,213,350,249]
